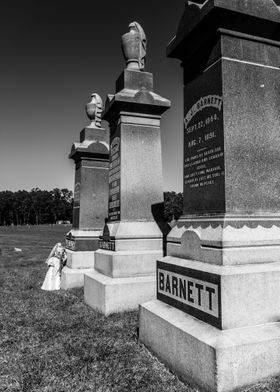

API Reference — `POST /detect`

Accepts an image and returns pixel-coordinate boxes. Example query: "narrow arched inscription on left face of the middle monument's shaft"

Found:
[109,136,121,221]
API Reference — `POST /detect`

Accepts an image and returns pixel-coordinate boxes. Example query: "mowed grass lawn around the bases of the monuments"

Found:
[0,226,280,392]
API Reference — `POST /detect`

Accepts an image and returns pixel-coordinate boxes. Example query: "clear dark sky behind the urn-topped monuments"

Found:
[0,0,185,192]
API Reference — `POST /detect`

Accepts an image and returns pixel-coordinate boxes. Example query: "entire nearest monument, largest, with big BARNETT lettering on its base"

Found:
[140,0,280,392]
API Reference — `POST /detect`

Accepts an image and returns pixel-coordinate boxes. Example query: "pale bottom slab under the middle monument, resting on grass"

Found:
[84,272,156,315]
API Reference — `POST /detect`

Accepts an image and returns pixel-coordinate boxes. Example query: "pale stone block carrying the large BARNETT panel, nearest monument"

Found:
[157,256,280,330]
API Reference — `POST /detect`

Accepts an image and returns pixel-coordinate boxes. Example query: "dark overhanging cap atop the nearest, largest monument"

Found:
[167,0,280,59]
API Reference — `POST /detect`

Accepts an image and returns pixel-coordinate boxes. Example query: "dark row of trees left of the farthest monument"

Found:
[0,188,73,226]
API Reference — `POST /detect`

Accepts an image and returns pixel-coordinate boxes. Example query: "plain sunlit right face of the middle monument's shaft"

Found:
[121,124,163,221]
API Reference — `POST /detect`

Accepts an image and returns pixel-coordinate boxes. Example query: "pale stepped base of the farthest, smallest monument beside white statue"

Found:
[60,249,95,290]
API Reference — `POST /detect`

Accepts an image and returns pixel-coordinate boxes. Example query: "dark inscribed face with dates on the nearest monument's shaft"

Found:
[184,64,225,214]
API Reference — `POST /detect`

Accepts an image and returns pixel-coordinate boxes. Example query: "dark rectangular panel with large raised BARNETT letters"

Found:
[157,261,222,329]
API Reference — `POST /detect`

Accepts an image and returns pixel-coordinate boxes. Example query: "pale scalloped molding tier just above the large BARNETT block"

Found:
[167,226,280,266]
